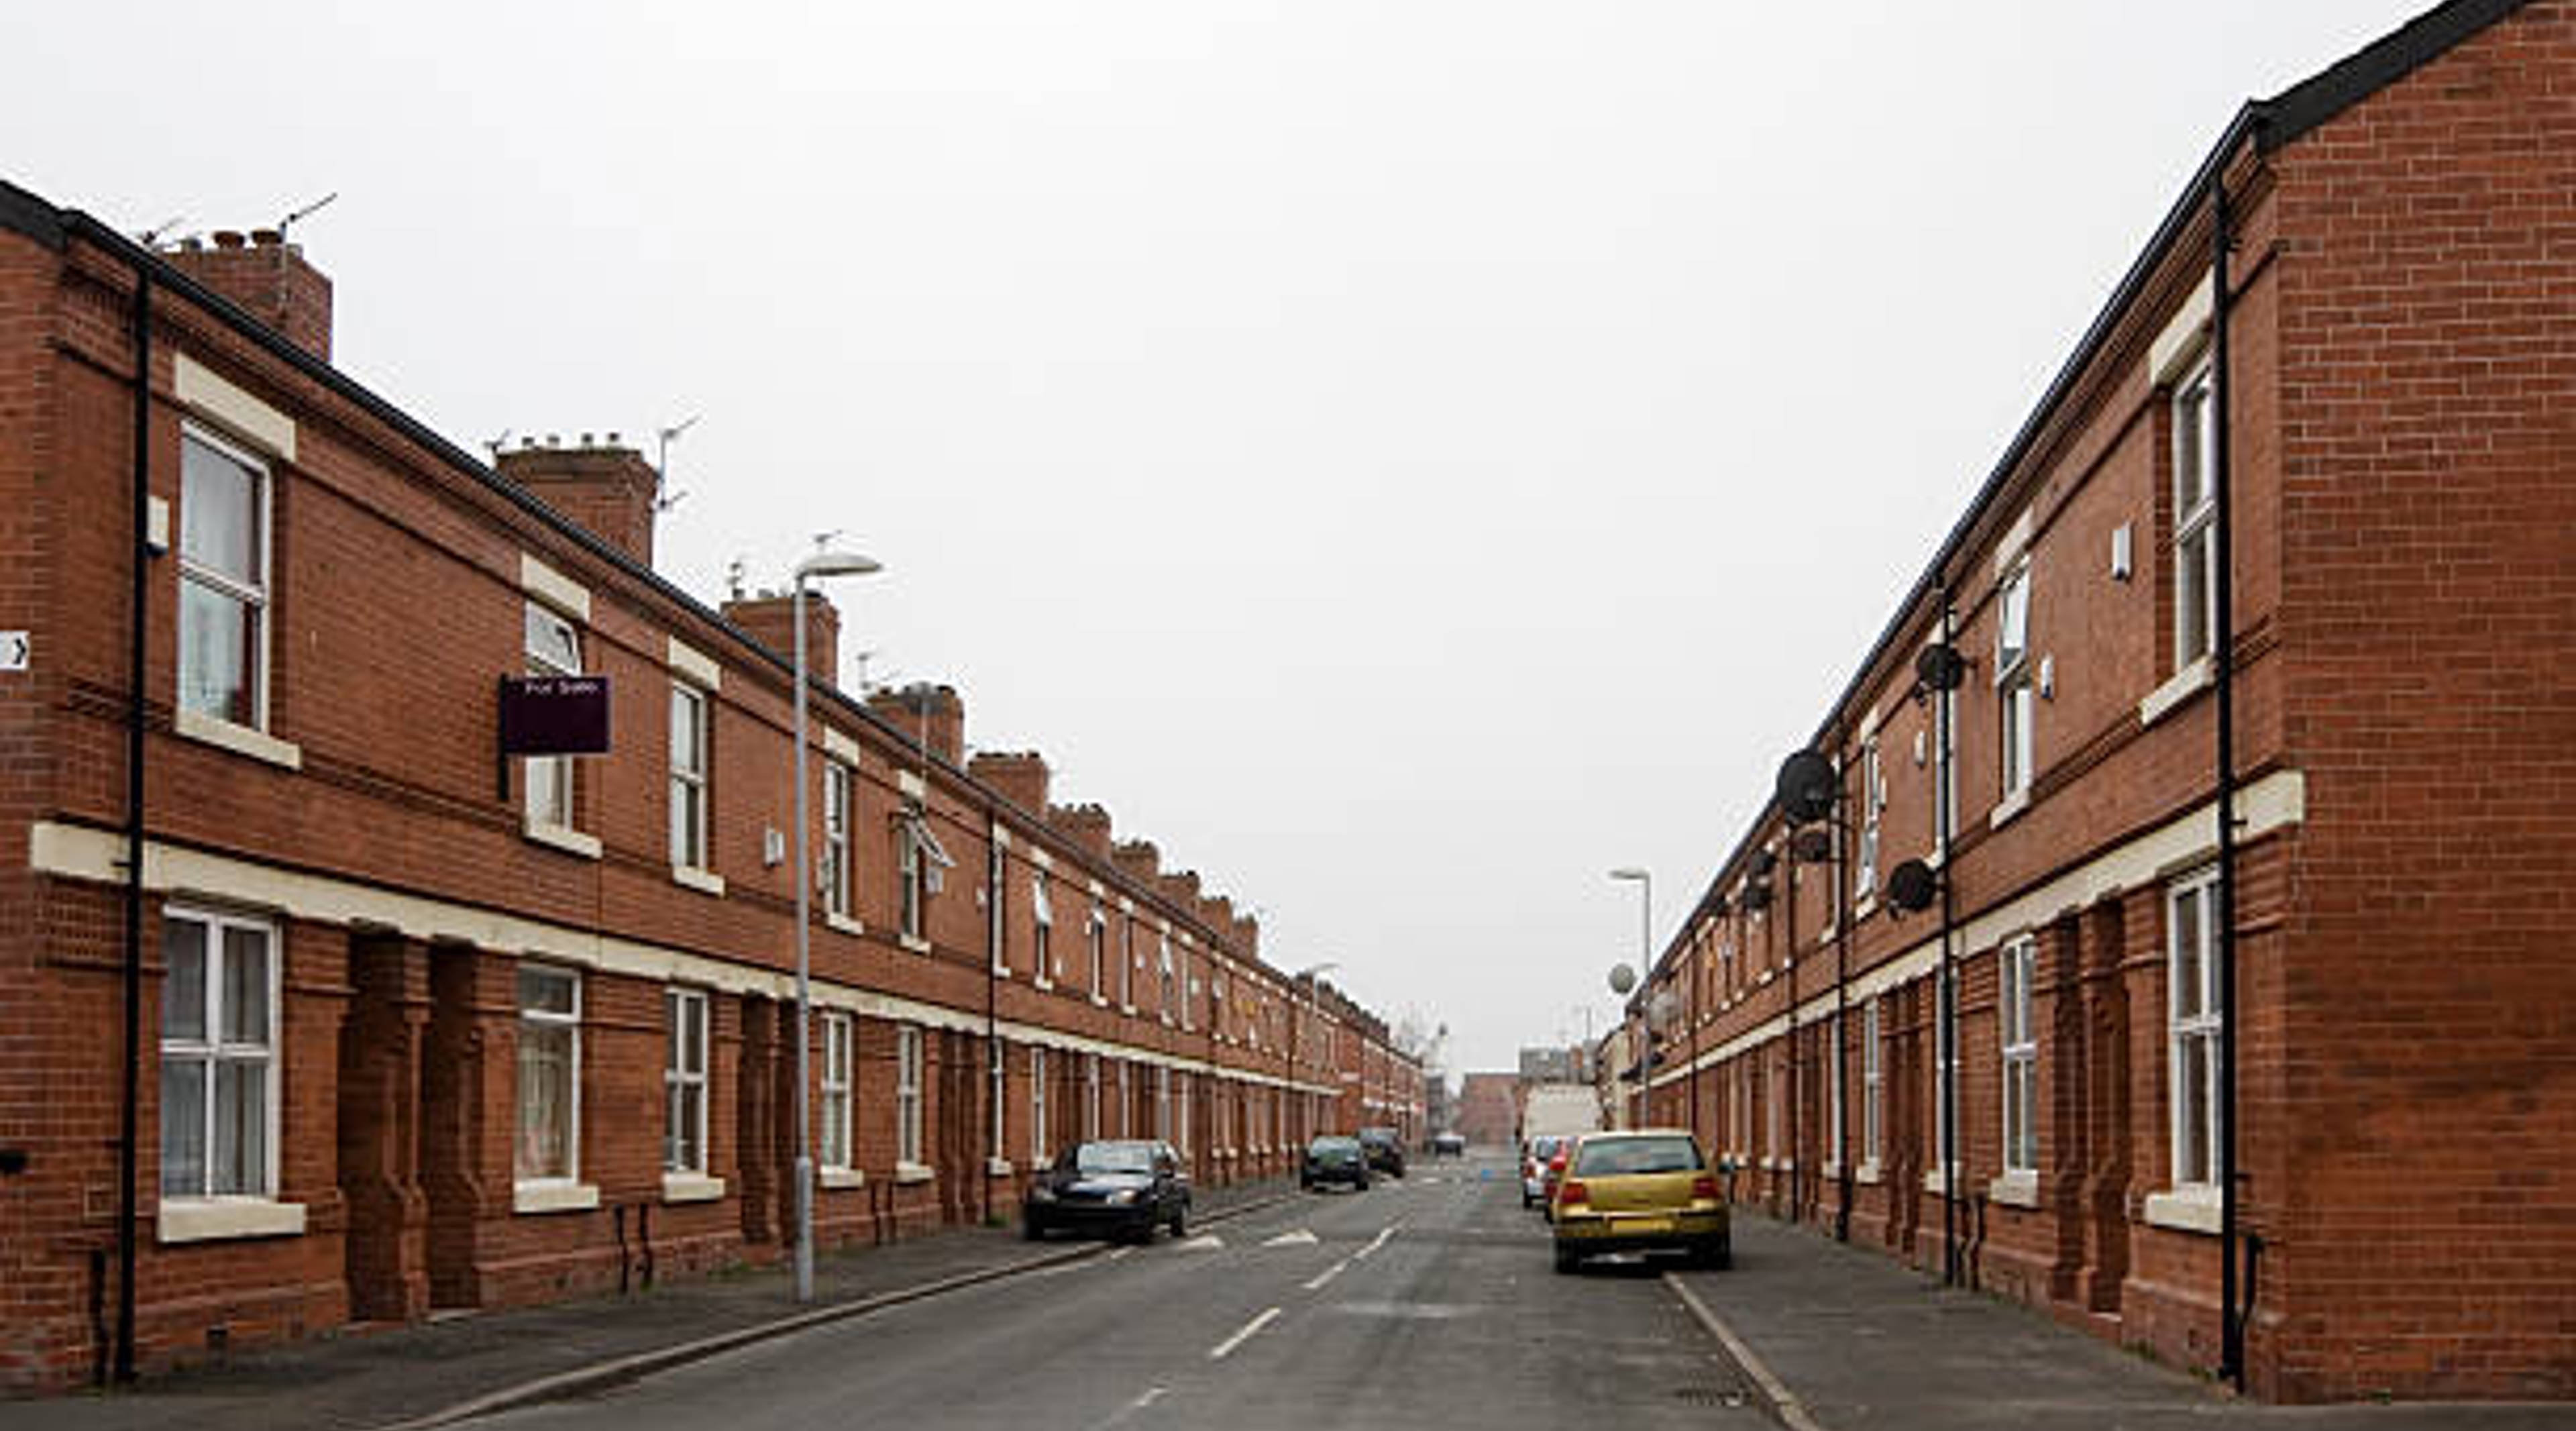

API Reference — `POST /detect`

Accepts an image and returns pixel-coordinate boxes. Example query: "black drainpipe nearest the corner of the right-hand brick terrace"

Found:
[2210,160,2246,1392]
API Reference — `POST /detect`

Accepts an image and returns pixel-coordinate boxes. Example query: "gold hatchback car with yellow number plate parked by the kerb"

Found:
[1548,1129,1733,1271]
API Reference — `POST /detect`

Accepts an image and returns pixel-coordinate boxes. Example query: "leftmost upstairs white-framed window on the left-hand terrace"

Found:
[178,428,268,730]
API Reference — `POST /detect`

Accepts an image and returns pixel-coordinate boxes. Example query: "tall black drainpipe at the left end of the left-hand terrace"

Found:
[116,266,152,1382]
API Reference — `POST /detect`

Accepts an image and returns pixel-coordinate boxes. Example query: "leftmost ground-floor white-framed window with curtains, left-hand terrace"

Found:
[160,910,278,1196]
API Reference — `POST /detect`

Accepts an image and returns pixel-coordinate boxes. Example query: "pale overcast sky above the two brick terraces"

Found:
[0,0,2429,1067]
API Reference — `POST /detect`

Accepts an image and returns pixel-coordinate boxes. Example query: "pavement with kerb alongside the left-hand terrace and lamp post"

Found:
[28,1178,1296,1431]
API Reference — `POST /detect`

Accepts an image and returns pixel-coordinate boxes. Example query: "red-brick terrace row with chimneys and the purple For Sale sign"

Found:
[0,174,1419,1387]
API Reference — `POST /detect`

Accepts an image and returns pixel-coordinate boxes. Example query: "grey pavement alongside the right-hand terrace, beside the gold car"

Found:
[1664,1209,2576,1431]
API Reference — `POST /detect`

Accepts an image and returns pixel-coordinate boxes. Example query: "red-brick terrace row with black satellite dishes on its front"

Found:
[1625,0,2576,1400]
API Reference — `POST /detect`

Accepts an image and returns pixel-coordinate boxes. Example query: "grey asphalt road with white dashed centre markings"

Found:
[476,1158,1764,1431]
